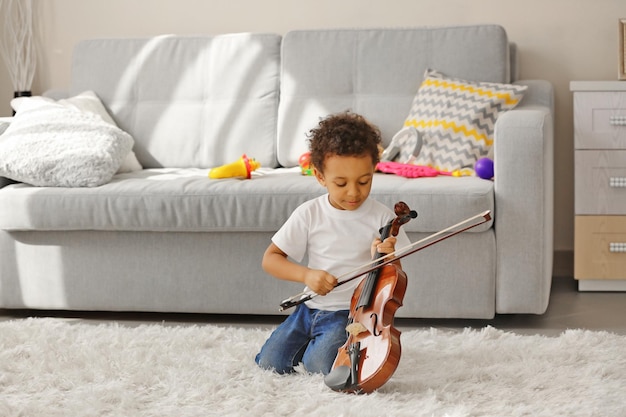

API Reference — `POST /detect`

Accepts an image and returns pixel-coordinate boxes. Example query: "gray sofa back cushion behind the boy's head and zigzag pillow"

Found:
[276,25,511,167]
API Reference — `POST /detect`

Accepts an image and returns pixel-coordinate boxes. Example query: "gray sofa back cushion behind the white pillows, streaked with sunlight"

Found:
[70,33,281,168]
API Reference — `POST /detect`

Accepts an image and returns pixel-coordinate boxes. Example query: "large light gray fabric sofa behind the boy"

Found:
[0,25,554,318]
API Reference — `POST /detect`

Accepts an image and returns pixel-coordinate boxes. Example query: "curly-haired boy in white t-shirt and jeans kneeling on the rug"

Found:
[256,113,410,374]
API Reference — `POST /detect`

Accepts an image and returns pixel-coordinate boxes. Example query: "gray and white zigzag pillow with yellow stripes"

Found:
[404,69,528,175]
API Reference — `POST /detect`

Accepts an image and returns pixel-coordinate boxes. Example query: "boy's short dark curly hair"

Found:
[307,111,382,172]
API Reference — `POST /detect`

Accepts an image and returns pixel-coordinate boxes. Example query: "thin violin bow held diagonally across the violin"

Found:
[278,210,491,311]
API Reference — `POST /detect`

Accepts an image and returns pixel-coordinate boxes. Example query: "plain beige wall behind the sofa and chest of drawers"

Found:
[0,0,626,262]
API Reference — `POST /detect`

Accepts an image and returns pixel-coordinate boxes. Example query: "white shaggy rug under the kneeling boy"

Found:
[0,319,626,417]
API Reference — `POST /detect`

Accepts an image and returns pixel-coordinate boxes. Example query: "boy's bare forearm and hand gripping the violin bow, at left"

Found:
[261,243,337,295]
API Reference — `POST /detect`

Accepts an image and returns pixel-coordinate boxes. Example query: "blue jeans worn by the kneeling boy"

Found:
[255,304,350,375]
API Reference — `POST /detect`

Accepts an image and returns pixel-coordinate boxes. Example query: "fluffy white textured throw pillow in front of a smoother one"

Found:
[0,102,134,187]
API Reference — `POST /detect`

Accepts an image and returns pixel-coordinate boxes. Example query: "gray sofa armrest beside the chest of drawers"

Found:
[494,81,554,314]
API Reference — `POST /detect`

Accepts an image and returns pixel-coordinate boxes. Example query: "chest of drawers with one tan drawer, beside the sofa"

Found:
[570,81,626,291]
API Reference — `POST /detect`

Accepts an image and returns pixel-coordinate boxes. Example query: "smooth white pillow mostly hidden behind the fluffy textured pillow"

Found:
[11,91,143,174]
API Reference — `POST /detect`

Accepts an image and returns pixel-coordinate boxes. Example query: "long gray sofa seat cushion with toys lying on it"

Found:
[0,168,494,232]
